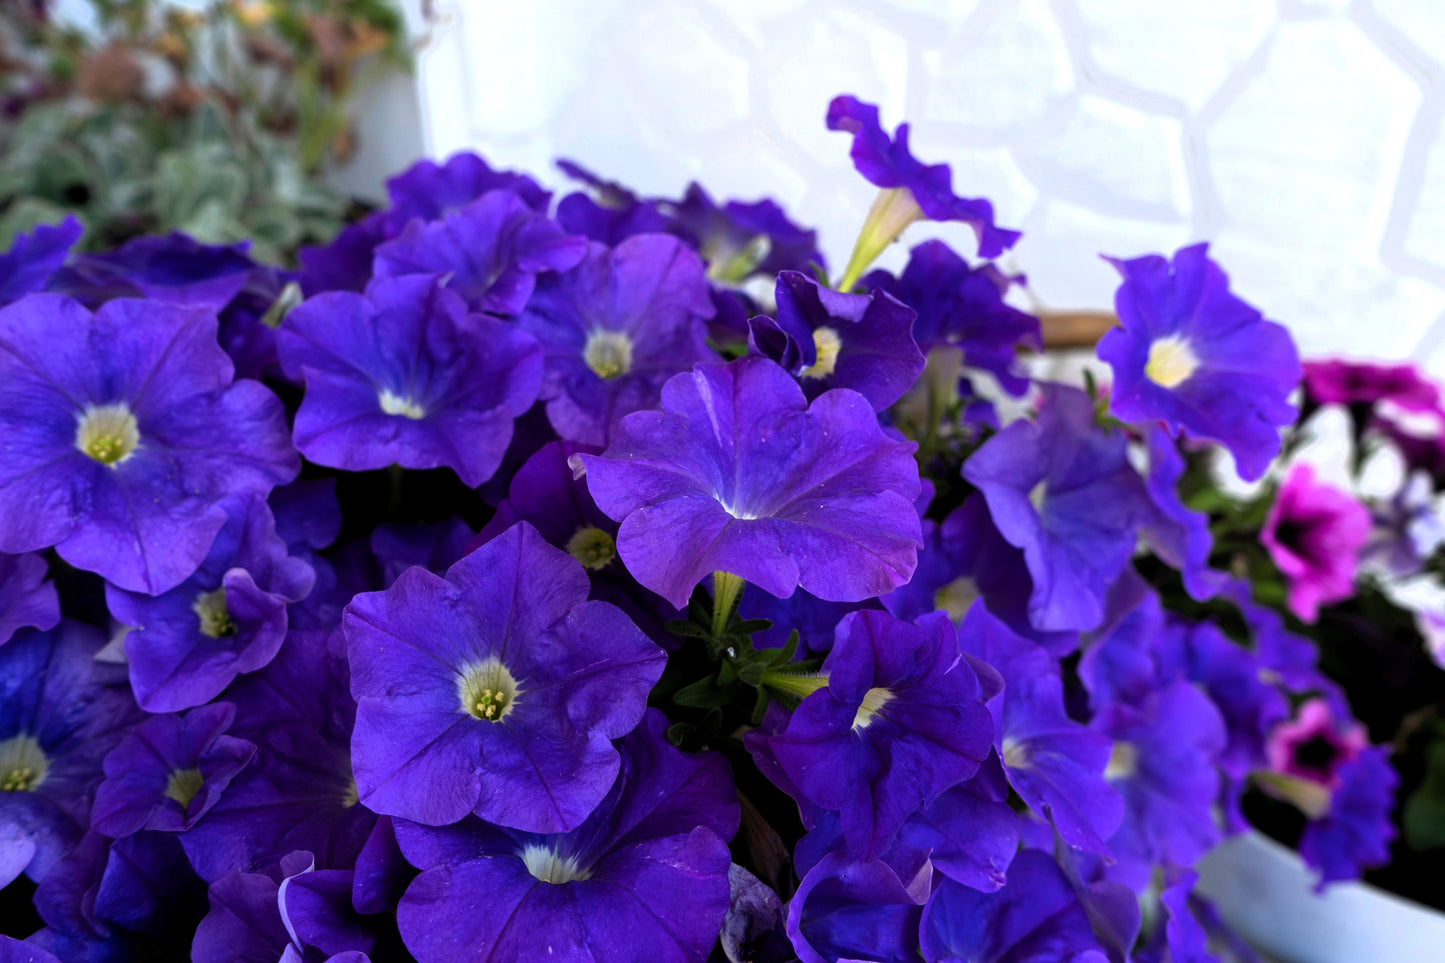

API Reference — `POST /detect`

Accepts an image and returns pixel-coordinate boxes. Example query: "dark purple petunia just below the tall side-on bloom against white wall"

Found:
[863,240,1043,396]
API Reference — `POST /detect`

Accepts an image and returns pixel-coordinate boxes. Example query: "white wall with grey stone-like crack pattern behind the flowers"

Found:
[422,0,1445,368]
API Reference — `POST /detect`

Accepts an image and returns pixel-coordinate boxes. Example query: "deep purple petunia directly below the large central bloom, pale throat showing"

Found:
[769,612,993,859]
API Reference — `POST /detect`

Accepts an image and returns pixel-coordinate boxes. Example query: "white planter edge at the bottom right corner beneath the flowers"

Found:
[1199,831,1445,963]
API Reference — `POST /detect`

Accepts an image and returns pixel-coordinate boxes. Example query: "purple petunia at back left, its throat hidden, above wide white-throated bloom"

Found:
[374,191,587,315]
